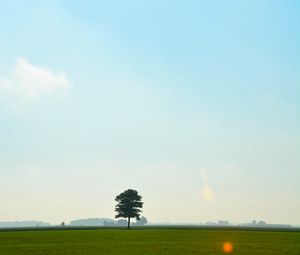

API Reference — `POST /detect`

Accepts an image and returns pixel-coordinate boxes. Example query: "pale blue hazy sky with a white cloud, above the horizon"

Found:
[0,0,300,225]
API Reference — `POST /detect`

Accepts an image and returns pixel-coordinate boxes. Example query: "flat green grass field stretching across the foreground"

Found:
[0,229,300,255]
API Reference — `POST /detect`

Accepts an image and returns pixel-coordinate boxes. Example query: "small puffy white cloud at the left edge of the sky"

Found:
[0,58,70,104]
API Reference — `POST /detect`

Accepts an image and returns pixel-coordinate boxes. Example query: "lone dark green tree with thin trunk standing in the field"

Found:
[115,189,143,229]
